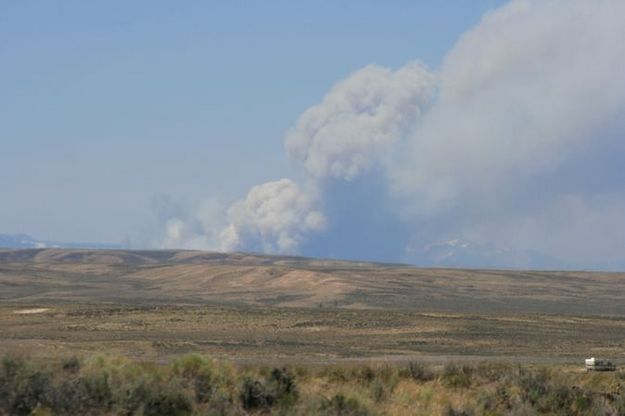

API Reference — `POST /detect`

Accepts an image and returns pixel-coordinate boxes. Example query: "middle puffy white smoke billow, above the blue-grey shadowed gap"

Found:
[285,62,436,181]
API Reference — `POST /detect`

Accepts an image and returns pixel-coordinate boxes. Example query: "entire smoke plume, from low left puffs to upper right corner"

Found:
[154,0,625,266]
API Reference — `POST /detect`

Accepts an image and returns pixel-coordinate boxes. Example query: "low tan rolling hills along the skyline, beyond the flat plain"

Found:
[0,249,625,315]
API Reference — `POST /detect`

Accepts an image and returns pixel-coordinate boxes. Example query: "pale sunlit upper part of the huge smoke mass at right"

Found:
[396,0,625,211]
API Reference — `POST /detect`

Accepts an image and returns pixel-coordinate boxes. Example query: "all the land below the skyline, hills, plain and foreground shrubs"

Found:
[0,249,625,414]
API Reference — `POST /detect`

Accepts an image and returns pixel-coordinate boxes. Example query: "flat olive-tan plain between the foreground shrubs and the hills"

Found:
[0,302,625,364]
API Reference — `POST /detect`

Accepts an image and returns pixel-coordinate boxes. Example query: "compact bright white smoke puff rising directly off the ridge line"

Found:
[220,179,326,253]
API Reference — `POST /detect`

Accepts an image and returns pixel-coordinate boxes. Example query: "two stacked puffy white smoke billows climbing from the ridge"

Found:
[205,62,435,253]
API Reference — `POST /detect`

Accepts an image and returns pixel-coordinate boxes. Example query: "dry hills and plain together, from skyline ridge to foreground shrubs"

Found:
[0,249,625,363]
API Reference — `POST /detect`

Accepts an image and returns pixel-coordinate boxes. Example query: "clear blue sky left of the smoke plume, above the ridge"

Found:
[0,0,499,242]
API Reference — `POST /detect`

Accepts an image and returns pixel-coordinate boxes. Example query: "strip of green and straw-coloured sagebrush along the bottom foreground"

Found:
[0,354,625,416]
